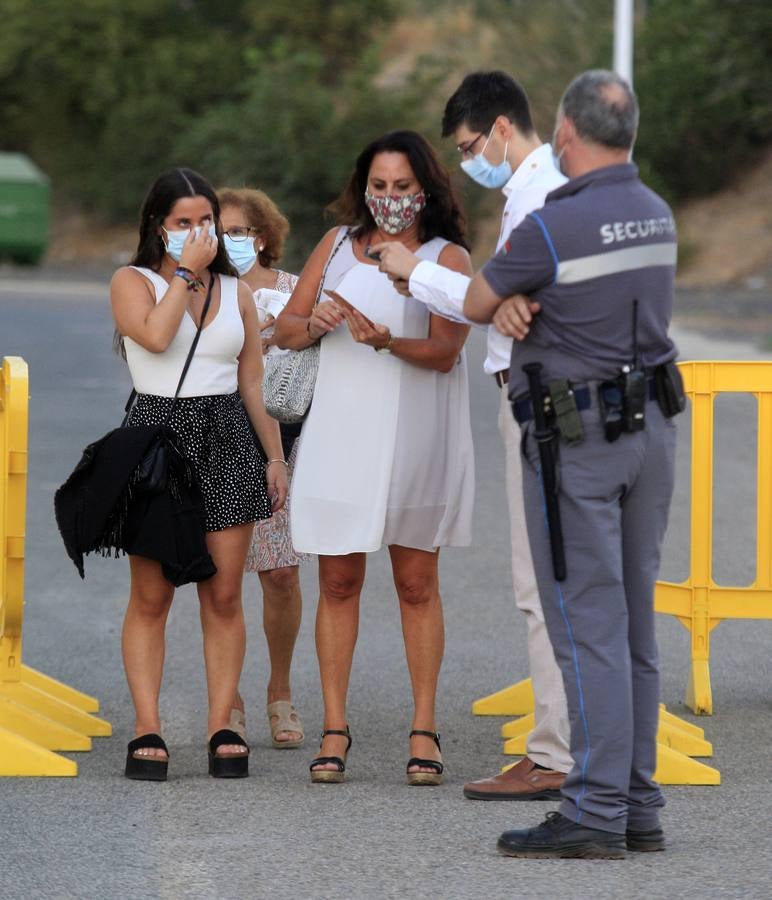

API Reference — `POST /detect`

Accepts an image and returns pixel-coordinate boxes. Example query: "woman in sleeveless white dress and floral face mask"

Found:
[275,131,474,784]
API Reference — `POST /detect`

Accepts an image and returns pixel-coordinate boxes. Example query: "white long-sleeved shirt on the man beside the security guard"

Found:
[410,144,567,375]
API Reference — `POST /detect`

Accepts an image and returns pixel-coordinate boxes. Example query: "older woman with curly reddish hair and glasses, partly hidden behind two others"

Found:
[218,188,304,749]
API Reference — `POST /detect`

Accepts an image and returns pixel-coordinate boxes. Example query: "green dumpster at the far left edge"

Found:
[0,153,51,265]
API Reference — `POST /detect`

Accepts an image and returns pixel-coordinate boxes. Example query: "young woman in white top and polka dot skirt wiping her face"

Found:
[110,169,287,780]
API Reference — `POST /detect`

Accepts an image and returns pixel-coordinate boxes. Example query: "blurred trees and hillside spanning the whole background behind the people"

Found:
[0,0,772,264]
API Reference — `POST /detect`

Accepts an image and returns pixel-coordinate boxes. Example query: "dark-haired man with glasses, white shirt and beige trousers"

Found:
[371,72,573,800]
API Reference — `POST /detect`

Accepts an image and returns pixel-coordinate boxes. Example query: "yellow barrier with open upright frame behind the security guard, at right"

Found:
[655,362,772,715]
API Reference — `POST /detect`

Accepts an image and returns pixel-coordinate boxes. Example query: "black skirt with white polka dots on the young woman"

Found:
[126,392,271,531]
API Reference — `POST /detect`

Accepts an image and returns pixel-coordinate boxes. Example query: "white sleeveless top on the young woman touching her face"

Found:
[123,266,244,397]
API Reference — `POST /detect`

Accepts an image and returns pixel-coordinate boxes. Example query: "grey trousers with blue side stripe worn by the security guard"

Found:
[522,404,675,833]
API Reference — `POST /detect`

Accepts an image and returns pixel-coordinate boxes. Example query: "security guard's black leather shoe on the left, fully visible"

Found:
[497,813,627,859]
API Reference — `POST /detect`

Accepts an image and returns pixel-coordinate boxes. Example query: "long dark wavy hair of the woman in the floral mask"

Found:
[329,131,469,250]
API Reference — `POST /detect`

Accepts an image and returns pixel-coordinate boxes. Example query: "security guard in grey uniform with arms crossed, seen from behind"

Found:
[464,70,684,859]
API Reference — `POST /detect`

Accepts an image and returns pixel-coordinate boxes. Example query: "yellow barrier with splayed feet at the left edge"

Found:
[0,356,112,775]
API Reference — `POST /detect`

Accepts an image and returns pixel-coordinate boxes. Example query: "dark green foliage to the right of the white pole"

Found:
[636,0,772,199]
